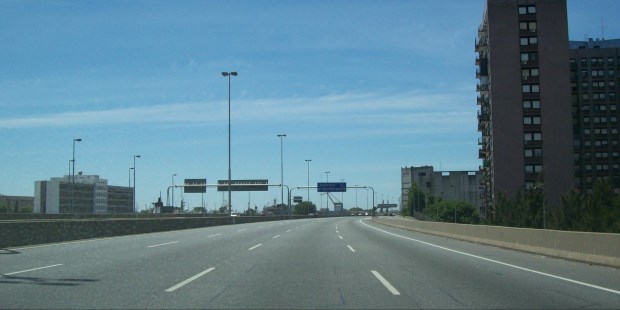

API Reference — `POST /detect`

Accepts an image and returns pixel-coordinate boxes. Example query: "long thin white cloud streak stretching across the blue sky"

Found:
[0,92,475,132]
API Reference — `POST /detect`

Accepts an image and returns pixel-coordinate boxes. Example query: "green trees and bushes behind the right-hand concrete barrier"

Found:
[402,181,620,233]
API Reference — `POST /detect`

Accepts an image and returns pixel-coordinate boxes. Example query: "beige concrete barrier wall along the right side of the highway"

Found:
[373,217,620,268]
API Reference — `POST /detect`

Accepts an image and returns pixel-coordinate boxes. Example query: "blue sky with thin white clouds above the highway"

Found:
[0,0,620,210]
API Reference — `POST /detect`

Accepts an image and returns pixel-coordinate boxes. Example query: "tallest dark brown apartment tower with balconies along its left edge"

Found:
[475,0,574,216]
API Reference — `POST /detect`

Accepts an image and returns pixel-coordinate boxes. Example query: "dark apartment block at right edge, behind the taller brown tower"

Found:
[569,39,620,193]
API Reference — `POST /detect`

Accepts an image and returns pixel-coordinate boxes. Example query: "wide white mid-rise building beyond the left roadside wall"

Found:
[34,175,134,214]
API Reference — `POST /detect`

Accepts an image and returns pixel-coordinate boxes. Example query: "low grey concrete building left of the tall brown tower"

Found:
[400,166,482,212]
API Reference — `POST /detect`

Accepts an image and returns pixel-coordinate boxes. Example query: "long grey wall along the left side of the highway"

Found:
[0,216,306,248]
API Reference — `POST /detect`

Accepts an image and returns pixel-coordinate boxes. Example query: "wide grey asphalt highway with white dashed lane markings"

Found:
[0,216,620,309]
